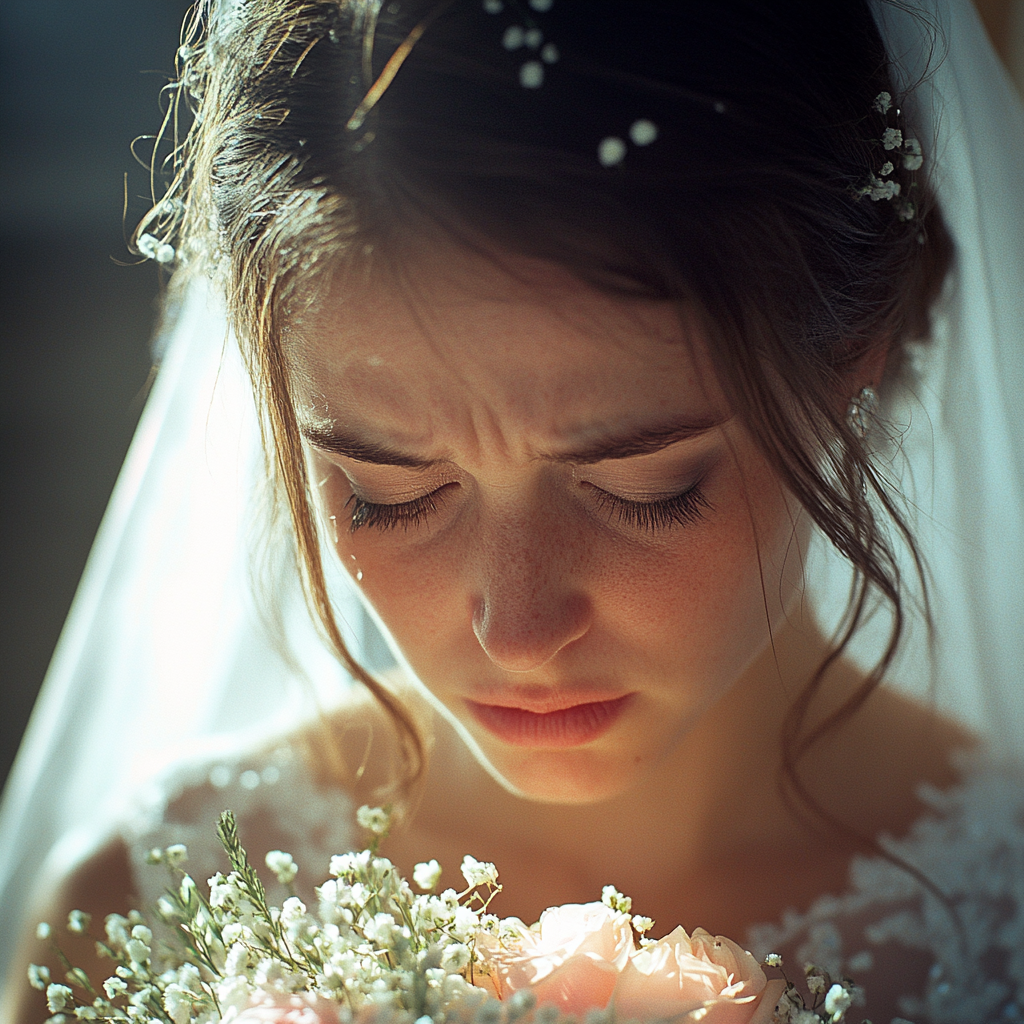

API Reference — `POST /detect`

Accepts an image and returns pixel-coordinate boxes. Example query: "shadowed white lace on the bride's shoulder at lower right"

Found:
[749,758,1024,1024]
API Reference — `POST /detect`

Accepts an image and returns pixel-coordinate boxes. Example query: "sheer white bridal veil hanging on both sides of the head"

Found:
[0,0,1024,991]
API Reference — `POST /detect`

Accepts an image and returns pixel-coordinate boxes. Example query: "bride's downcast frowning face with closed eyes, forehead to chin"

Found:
[286,251,799,803]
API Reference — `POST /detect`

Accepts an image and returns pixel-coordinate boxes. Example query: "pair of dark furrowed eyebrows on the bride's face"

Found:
[300,418,725,469]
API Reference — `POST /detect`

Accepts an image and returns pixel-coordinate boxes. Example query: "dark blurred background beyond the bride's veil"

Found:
[0,0,1024,785]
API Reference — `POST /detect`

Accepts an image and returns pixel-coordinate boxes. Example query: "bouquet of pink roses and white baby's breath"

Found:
[29,807,856,1024]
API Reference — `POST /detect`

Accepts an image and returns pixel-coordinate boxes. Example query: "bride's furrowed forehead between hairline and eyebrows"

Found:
[286,249,723,443]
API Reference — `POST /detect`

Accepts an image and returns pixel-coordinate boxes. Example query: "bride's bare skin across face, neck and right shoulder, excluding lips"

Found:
[287,241,967,937]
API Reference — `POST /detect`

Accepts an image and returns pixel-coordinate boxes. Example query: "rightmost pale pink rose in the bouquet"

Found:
[614,928,785,1024]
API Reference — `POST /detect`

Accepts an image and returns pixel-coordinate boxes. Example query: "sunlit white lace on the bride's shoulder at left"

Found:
[122,743,355,906]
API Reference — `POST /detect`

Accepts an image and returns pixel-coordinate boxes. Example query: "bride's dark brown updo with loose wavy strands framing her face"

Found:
[138,0,949,815]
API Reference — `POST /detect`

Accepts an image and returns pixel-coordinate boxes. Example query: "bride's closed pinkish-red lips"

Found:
[466,693,635,748]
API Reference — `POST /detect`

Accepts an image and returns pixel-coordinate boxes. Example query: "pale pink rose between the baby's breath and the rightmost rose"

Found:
[481,903,636,1014]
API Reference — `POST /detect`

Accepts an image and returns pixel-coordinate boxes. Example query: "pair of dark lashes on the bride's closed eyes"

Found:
[345,484,711,534]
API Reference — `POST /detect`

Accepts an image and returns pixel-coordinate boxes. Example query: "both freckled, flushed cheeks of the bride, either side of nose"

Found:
[318,444,799,703]
